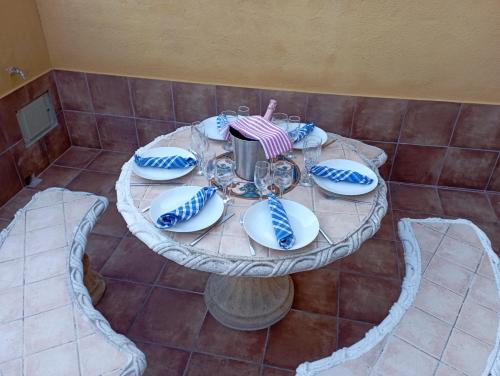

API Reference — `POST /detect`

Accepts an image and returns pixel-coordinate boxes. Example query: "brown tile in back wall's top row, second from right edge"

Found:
[399,101,460,146]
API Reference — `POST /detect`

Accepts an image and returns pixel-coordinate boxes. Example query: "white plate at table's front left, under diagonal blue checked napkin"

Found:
[149,185,224,232]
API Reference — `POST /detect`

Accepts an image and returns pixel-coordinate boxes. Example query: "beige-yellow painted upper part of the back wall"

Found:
[37,0,500,103]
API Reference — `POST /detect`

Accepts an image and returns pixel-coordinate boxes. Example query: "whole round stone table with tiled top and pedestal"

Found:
[116,127,387,330]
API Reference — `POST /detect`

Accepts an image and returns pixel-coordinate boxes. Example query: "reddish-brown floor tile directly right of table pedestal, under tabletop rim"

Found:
[292,268,339,316]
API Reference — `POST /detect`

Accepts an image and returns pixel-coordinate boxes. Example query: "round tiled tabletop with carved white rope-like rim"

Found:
[116,127,387,277]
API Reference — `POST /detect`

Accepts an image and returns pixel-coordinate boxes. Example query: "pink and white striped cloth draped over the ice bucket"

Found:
[223,115,292,159]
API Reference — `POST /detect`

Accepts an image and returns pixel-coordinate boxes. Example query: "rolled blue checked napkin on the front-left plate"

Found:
[155,187,217,229]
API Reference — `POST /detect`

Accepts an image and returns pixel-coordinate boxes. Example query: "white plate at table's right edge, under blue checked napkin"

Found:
[313,159,378,196]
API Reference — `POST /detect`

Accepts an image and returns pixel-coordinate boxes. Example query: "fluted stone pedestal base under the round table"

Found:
[205,274,294,330]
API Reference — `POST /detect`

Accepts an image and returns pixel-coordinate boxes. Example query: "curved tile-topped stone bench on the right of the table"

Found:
[297,218,500,376]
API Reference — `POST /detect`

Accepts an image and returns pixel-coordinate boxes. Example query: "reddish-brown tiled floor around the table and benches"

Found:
[0,147,500,376]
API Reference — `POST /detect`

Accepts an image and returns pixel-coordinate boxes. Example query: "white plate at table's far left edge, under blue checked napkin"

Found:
[132,147,196,180]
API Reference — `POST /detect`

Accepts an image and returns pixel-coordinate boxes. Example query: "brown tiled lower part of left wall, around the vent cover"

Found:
[0,72,71,205]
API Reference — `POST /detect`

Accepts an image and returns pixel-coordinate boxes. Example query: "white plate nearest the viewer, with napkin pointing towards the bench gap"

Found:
[243,200,319,251]
